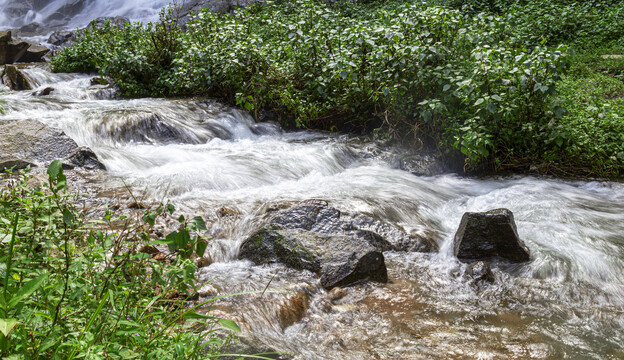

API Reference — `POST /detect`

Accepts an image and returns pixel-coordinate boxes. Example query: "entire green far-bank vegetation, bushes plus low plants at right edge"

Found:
[52,0,624,176]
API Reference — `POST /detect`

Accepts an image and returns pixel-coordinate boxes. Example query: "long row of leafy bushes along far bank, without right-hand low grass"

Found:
[52,0,567,172]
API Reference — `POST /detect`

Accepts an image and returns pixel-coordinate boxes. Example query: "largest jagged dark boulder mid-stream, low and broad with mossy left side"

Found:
[240,200,431,289]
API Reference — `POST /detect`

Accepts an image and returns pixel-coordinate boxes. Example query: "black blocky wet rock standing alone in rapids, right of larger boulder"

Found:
[453,209,530,262]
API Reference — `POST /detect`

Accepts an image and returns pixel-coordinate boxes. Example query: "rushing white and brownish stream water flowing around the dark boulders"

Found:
[0,68,624,359]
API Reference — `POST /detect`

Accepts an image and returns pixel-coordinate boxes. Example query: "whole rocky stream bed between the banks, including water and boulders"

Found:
[0,65,624,359]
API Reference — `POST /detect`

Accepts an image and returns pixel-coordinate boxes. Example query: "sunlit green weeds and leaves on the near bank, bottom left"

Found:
[0,161,240,359]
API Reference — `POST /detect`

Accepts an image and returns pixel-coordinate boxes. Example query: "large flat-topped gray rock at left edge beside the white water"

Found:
[0,120,103,171]
